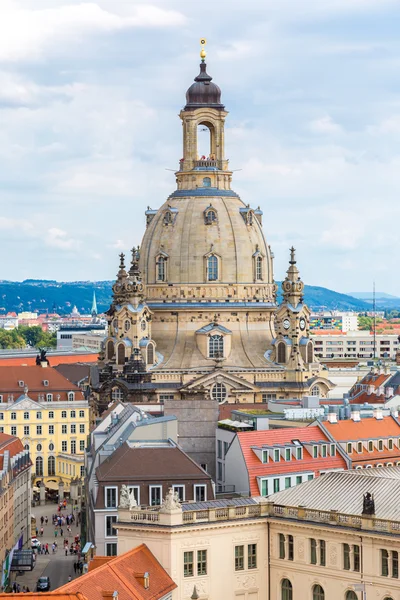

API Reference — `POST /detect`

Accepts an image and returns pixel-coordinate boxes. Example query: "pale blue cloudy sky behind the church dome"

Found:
[0,0,400,295]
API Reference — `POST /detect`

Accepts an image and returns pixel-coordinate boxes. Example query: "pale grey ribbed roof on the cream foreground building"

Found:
[268,467,400,521]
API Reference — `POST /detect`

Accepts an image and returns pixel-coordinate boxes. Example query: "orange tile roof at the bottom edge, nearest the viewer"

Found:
[57,544,177,600]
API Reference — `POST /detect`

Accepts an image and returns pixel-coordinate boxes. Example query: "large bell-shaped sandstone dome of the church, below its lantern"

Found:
[140,189,273,301]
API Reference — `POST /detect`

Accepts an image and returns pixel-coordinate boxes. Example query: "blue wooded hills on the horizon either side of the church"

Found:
[0,279,376,314]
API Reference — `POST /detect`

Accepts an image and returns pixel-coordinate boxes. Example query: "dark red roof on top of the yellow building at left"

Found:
[0,365,84,402]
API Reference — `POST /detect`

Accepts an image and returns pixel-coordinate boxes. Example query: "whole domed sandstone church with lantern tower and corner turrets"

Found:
[92,43,333,422]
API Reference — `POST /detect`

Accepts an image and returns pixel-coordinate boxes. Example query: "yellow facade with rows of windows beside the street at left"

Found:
[0,394,89,491]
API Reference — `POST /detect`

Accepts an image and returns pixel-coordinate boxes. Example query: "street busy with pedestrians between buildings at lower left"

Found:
[11,503,80,592]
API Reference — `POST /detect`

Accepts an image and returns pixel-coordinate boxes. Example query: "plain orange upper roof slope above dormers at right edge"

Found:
[324,416,400,442]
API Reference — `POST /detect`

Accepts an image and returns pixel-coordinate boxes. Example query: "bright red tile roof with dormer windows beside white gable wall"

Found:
[237,425,346,496]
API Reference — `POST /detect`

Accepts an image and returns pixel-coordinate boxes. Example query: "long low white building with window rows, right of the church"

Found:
[311,331,399,360]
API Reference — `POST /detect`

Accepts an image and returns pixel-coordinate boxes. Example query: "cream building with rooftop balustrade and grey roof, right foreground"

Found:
[116,467,400,600]
